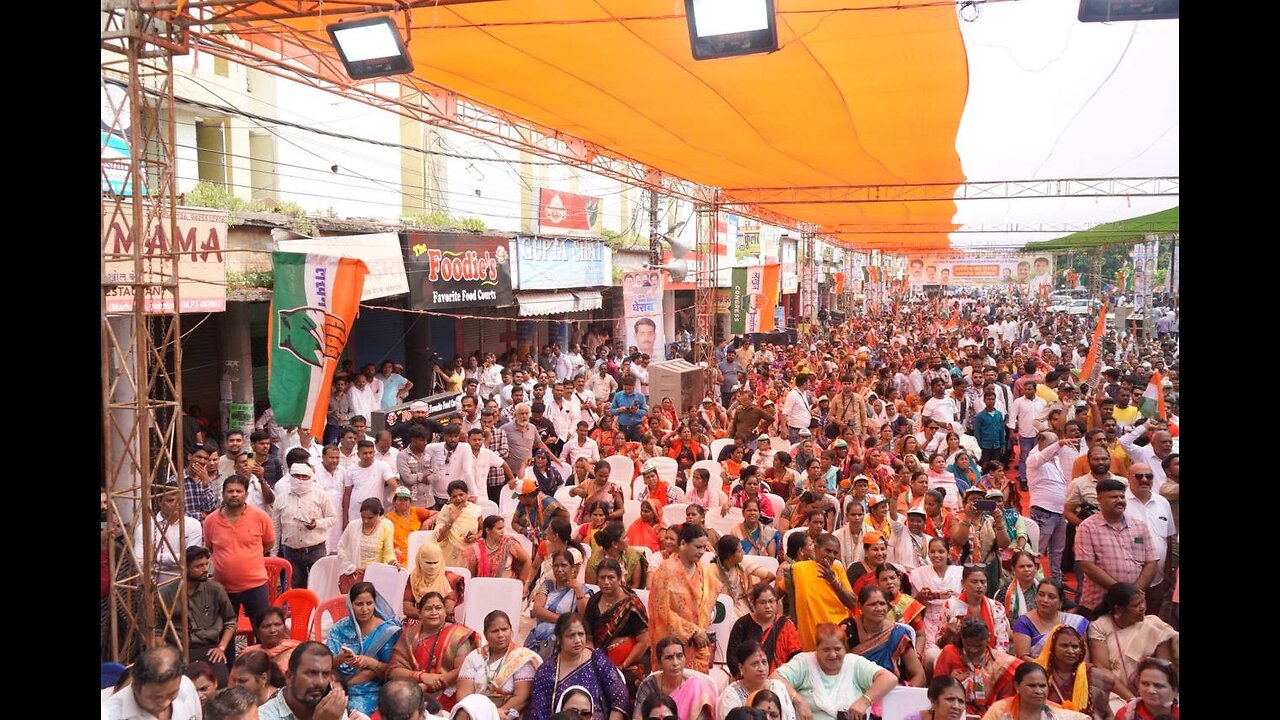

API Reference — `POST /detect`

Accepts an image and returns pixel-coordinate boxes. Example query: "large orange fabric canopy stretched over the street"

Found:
[220,0,969,249]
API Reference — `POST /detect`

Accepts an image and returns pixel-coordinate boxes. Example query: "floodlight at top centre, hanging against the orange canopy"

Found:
[685,0,778,60]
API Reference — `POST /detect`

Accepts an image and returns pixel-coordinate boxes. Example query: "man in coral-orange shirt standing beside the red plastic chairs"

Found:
[204,475,275,666]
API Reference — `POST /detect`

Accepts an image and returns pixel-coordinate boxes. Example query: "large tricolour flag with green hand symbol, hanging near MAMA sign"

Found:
[266,252,369,437]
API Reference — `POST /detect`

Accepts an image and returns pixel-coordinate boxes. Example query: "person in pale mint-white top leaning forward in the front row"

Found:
[773,623,897,720]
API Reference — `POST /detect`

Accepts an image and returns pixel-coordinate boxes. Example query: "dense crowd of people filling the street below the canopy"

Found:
[102,290,1179,720]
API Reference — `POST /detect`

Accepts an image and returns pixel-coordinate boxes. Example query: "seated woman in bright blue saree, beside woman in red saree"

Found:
[325,582,401,715]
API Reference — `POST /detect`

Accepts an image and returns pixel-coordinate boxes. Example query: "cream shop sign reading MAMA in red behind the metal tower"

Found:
[102,202,227,313]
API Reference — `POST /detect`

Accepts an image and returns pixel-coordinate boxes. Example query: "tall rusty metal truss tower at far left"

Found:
[99,0,187,664]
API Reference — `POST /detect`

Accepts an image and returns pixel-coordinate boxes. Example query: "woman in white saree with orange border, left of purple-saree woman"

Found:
[458,610,543,717]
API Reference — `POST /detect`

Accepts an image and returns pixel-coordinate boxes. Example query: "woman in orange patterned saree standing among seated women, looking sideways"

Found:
[649,524,721,673]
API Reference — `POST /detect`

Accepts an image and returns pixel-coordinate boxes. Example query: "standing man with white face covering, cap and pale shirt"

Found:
[275,462,337,588]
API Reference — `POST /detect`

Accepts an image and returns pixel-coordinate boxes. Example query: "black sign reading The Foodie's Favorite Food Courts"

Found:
[401,232,512,310]
